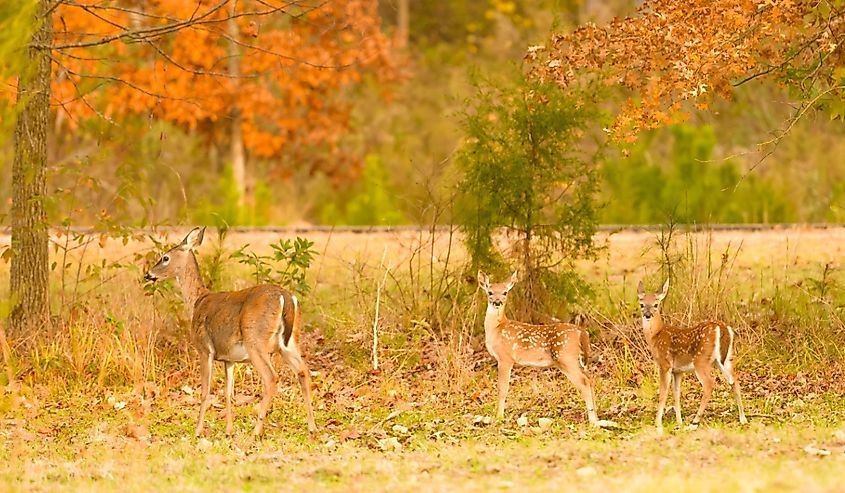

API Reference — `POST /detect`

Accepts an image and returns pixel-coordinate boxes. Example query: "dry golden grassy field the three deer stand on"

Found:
[0,229,845,492]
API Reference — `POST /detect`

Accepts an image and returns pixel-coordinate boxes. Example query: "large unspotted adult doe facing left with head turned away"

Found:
[144,228,317,436]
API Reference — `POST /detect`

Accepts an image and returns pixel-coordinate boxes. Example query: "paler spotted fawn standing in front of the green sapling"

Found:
[478,271,602,426]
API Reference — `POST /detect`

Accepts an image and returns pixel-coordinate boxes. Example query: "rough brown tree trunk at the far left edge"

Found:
[9,0,53,337]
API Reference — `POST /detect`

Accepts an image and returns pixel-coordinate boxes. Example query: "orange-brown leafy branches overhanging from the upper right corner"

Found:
[526,0,845,141]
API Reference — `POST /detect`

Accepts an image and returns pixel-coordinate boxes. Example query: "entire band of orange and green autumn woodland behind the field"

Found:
[0,0,845,332]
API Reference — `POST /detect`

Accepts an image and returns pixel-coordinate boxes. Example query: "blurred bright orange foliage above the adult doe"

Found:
[53,0,397,174]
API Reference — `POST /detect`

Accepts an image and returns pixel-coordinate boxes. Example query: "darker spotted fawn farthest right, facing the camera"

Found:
[637,279,748,433]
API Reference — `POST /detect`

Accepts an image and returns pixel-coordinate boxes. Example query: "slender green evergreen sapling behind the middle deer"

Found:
[458,67,597,318]
